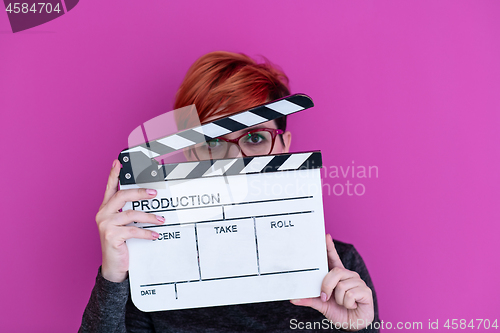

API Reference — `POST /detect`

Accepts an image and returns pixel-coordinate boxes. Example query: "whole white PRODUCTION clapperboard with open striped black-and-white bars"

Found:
[119,94,328,312]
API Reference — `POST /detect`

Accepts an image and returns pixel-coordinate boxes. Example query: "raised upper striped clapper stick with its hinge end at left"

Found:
[118,94,314,185]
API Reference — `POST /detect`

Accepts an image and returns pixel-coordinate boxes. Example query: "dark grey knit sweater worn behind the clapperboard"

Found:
[79,241,380,333]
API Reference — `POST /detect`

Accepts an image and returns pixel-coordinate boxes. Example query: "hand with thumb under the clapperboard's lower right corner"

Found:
[291,235,374,331]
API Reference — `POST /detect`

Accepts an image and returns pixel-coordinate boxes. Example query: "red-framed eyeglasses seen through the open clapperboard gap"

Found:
[191,128,283,161]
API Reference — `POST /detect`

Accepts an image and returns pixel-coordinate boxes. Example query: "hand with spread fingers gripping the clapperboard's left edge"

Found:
[95,160,165,282]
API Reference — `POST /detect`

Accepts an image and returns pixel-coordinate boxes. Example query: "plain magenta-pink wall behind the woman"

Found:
[0,0,500,332]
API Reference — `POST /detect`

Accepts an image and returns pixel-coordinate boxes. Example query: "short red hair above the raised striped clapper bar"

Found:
[174,51,290,130]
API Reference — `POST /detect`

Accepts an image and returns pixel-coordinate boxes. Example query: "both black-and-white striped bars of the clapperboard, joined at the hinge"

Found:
[118,94,322,185]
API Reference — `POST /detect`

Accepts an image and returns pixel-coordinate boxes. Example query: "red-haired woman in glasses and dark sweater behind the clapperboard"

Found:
[80,52,378,332]
